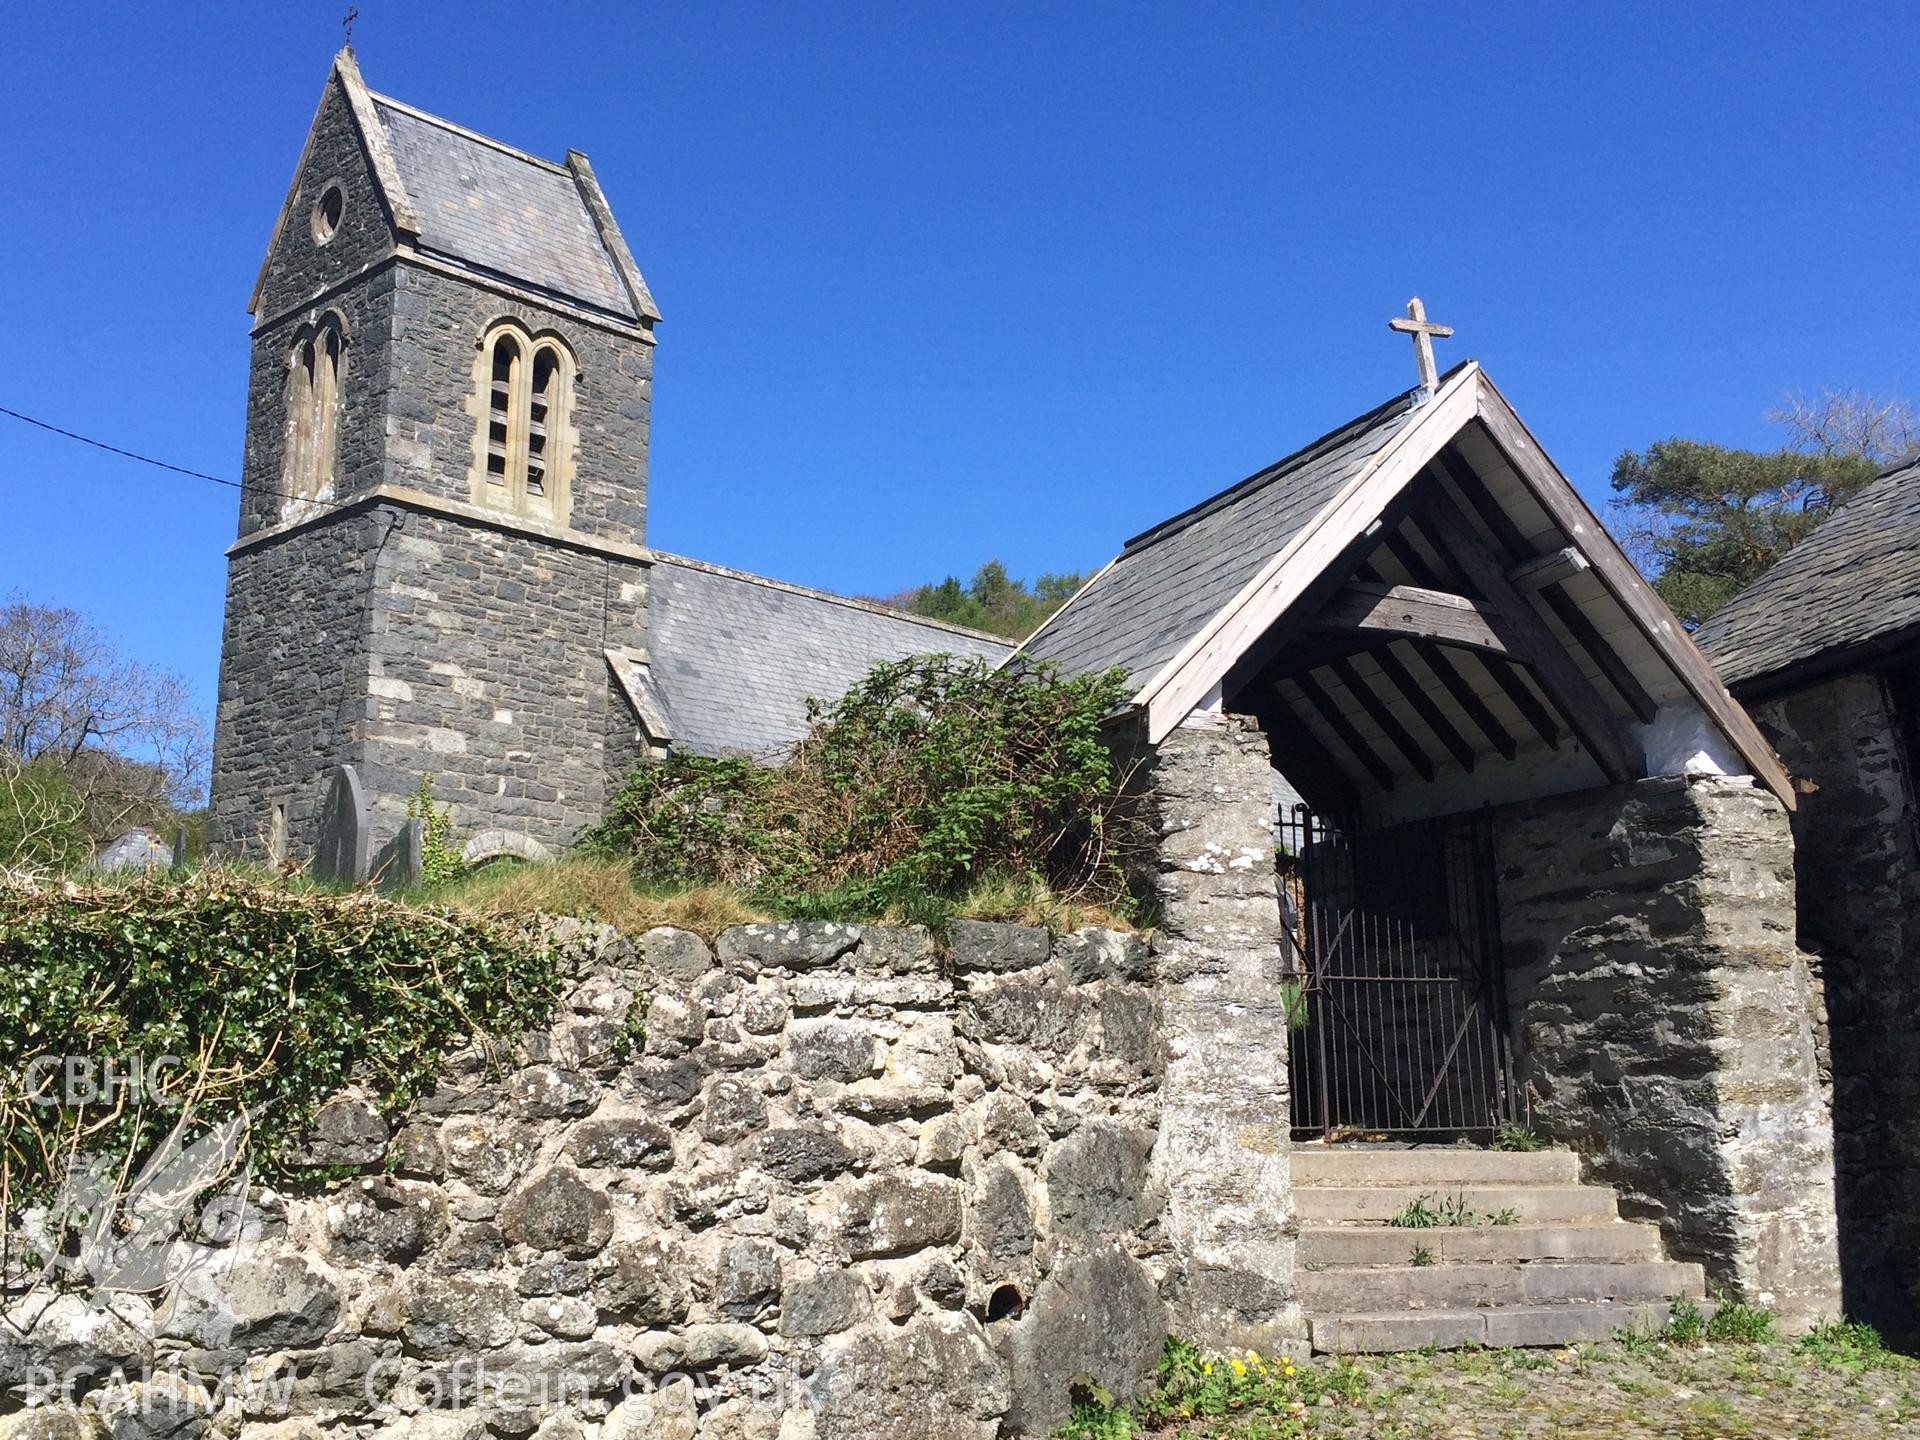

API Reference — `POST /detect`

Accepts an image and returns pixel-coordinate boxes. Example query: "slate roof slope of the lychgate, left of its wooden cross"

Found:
[1021,390,1419,685]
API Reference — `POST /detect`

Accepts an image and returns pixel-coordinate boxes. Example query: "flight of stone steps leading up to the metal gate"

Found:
[1294,1146,1707,1352]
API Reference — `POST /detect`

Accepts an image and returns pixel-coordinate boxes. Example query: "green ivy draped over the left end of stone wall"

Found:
[0,872,561,1204]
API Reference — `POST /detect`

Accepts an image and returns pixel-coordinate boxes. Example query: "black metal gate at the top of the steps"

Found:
[1279,806,1517,1135]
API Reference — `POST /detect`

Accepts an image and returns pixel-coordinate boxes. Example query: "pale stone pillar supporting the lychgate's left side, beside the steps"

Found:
[1137,716,1306,1354]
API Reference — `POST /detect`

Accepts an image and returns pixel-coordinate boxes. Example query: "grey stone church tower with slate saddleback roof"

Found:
[211,50,659,856]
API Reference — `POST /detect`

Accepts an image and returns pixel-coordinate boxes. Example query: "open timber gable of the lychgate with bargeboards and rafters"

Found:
[1123,361,1793,806]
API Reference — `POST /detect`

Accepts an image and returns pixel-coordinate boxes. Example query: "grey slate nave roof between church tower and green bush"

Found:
[647,555,1012,755]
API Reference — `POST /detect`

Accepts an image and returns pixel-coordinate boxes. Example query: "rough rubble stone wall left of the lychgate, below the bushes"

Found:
[0,922,1169,1440]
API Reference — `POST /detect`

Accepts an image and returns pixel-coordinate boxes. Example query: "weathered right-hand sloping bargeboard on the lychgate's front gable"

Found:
[1475,374,1797,810]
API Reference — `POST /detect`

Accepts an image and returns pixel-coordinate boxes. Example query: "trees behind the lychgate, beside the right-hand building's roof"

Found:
[1613,390,1920,628]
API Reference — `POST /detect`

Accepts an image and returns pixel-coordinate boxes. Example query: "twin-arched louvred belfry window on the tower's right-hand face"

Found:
[474,323,574,522]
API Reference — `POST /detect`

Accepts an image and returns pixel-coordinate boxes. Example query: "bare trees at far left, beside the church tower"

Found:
[0,597,207,860]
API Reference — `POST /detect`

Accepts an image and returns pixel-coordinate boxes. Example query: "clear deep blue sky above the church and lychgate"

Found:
[0,0,1920,721]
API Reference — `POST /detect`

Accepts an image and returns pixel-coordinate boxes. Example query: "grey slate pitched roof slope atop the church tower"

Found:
[372,94,637,321]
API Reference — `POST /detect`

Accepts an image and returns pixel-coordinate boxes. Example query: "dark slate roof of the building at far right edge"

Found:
[1693,463,1920,691]
